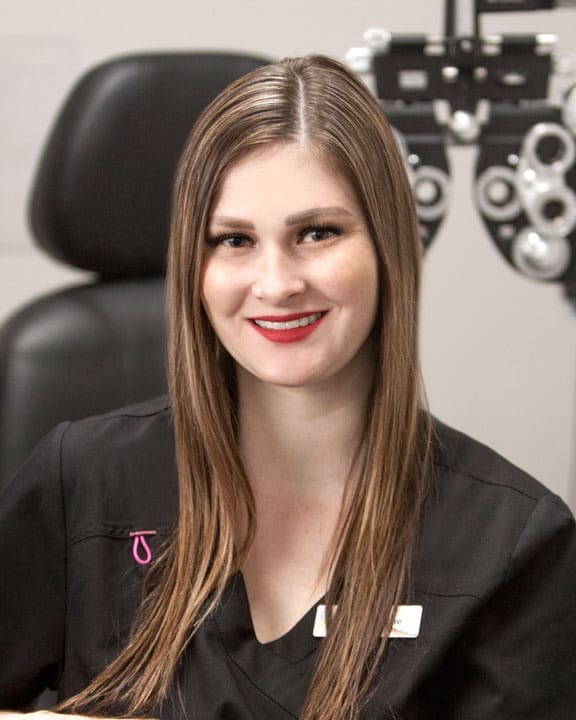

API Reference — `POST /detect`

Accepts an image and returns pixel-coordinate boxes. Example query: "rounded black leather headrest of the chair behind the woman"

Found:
[30,53,269,278]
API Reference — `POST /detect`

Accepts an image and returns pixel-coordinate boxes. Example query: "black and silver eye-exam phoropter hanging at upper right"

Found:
[347,0,576,303]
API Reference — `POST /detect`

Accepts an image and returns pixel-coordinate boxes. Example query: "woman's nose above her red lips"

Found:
[252,245,306,305]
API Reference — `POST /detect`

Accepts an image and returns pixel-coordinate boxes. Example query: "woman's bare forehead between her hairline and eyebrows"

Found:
[212,143,359,215]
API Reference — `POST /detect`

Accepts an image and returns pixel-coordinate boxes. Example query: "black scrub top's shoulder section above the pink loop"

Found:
[55,397,178,533]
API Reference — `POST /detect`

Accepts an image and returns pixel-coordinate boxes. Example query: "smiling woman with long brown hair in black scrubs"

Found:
[0,57,576,720]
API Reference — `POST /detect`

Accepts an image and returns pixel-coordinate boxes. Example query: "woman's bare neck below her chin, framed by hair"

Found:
[238,350,373,495]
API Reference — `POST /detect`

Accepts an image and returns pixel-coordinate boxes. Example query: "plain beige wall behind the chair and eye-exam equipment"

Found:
[0,0,576,501]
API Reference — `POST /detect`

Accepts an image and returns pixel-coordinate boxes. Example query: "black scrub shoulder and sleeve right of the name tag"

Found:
[400,421,576,720]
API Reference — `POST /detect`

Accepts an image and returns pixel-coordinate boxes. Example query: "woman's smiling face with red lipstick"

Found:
[202,143,378,386]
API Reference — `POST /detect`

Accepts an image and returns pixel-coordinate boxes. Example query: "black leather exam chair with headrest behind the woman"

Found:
[0,53,268,486]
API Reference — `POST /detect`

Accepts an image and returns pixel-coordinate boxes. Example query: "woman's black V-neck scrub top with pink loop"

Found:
[0,399,576,720]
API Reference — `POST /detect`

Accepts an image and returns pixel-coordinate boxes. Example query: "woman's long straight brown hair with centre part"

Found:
[61,56,429,720]
